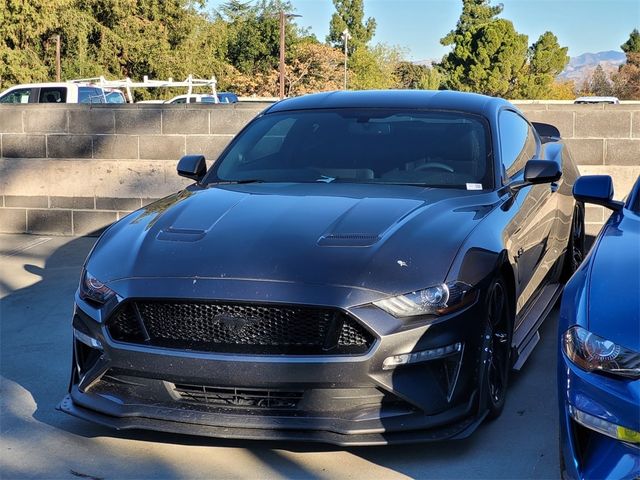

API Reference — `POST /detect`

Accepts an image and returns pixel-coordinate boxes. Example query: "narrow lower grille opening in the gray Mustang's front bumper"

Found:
[173,384,304,410]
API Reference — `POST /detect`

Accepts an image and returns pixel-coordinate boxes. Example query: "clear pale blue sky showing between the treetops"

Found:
[208,0,640,61]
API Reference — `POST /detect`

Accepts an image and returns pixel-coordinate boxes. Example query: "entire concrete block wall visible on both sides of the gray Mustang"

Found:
[0,102,640,235]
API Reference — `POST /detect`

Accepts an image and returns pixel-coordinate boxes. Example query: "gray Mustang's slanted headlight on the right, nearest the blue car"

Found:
[373,282,477,317]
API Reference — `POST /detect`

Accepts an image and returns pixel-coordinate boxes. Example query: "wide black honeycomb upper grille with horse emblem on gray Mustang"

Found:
[107,301,374,355]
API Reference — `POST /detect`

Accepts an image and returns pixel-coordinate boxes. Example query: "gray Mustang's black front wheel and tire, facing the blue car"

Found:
[480,277,513,419]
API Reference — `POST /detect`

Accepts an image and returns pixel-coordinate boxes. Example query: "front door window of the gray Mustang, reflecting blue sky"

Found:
[500,110,536,178]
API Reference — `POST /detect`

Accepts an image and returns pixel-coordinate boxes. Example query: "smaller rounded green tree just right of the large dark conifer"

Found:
[518,32,569,99]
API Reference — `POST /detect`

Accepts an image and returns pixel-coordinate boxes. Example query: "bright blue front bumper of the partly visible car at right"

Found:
[558,353,640,480]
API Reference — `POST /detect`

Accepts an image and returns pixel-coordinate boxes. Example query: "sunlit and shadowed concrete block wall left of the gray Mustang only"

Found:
[0,103,267,235]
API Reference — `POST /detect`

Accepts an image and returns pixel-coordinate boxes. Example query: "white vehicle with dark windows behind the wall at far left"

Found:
[0,82,126,103]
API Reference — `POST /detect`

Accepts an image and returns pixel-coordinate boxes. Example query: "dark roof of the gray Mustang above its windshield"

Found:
[267,90,510,116]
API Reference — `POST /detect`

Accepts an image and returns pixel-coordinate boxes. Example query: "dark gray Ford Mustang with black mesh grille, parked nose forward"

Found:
[60,91,584,445]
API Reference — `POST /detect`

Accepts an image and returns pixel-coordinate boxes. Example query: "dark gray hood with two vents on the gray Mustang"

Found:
[87,183,497,294]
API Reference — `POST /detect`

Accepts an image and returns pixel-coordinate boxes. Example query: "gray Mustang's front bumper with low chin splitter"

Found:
[59,278,490,445]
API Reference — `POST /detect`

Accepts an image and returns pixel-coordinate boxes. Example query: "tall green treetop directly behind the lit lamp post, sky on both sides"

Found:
[327,0,376,55]
